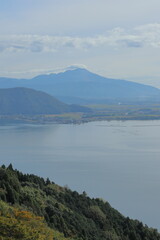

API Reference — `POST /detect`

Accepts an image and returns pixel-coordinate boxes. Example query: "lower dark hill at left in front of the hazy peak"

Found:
[0,88,90,115]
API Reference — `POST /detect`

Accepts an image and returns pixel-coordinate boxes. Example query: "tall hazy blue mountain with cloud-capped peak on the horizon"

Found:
[0,68,160,104]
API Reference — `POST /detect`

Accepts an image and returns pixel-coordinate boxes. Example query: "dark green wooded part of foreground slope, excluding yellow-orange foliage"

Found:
[0,165,160,240]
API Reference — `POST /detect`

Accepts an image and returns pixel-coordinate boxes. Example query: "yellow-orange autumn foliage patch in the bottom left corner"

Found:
[0,201,72,240]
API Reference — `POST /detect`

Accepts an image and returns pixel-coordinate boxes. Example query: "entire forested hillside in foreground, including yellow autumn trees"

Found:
[0,165,160,240]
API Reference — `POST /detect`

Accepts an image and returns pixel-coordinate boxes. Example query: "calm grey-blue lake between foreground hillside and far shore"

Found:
[0,120,160,230]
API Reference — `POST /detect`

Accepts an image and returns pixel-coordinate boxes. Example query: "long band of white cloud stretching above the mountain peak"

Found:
[0,23,160,53]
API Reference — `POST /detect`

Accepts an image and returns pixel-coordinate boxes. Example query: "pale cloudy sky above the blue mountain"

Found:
[0,0,160,88]
